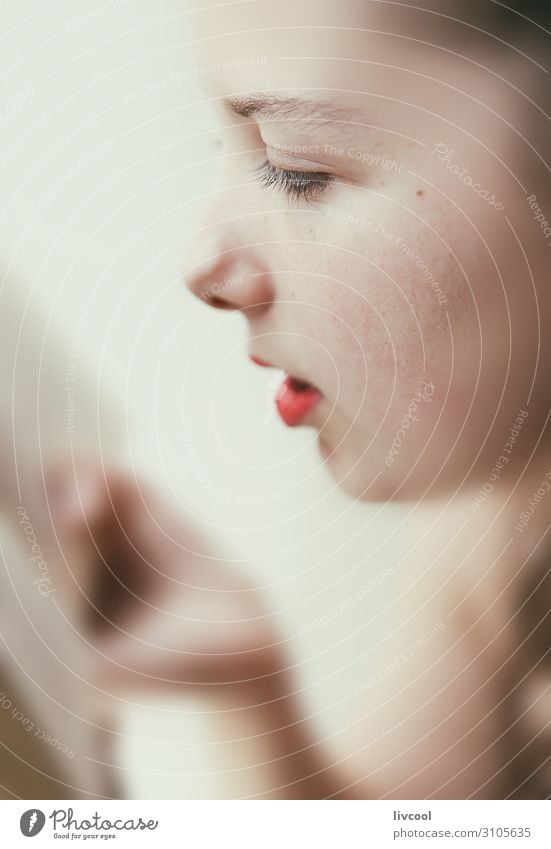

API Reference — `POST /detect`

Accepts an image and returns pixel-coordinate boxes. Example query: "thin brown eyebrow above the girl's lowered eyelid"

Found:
[224,93,350,124]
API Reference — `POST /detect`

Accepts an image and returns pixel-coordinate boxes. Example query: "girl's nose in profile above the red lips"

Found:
[185,228,275,315]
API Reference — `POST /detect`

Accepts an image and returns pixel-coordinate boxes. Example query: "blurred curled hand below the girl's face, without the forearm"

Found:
[42,466,284,687]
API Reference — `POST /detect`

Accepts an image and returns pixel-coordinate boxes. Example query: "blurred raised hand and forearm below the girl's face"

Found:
[38,460,358,798]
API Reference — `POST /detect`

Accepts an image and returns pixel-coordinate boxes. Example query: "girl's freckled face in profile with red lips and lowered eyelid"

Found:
[189,2,551,499]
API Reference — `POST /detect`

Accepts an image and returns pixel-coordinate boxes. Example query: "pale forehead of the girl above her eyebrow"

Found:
[190,0,474,104]
